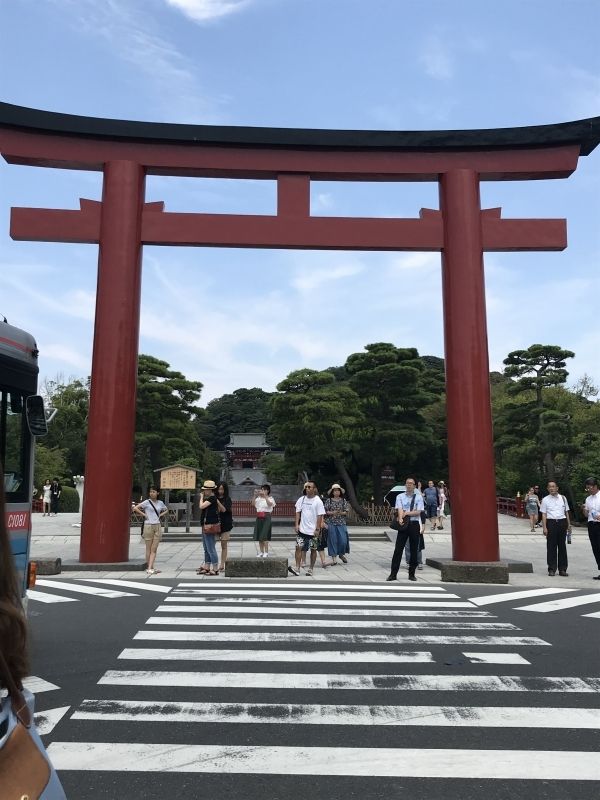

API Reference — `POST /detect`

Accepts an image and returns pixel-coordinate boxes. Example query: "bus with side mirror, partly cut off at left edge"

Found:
[0,318,48,598]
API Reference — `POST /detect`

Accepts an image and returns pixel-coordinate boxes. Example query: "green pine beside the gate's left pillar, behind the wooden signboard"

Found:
[134,355,202,493]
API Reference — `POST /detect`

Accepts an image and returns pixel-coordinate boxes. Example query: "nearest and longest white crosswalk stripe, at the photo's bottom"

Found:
[48,741,600,782]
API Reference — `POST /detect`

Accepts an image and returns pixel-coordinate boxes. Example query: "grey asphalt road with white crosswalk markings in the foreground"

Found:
[29,579,600,800]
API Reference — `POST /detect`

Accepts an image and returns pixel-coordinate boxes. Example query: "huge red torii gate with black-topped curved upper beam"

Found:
[0,103,600,580]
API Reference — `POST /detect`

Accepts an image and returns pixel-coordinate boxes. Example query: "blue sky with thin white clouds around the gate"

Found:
[0,0,600,404]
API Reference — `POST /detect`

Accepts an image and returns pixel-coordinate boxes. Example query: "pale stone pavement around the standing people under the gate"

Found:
[31,514,599,589]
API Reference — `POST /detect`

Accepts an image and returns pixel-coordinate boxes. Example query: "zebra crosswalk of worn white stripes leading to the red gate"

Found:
[43,581,600,784]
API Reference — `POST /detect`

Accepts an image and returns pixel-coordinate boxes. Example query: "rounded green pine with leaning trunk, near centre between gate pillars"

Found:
[270,369,365,516]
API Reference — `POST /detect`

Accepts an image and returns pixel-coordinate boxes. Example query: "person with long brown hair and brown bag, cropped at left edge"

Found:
[0,460,66,800]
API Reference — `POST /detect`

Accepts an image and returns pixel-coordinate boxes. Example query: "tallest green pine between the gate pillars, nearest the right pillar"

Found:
[345,342,439,503]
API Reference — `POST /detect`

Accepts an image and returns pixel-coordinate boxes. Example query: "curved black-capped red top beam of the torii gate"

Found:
[0,103,600,181]
